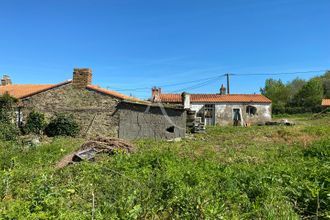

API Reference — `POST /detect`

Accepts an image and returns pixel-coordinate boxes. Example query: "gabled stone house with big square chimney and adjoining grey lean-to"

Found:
[0,68,185,139]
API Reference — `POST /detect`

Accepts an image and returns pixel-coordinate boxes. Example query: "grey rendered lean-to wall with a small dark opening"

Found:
[118,102,186,140]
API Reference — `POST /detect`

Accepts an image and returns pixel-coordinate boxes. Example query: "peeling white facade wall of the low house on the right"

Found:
[191,103,272,126]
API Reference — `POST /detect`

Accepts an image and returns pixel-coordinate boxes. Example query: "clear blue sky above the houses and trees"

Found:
[0,0,330,98]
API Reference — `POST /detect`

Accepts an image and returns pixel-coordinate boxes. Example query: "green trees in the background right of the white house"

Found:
[260,71,330,114]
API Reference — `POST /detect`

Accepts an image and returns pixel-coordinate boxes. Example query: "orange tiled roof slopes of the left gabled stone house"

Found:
[0,80,138,101]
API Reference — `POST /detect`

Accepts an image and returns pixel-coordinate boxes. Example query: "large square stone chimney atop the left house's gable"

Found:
[72,68,92,89]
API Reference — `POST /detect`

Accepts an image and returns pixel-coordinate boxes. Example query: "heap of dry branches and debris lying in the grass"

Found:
[56,137,134,168]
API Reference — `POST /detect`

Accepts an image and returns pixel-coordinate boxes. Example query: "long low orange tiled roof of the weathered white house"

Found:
[160,94,272,103]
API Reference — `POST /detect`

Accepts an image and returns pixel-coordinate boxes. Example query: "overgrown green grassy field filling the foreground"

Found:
[0,115,330,219]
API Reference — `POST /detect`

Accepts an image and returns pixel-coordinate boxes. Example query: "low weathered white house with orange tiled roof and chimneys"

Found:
[152,85,272,126]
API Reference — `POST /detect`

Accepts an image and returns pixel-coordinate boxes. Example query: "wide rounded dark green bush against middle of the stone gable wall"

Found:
[45,114,80,137]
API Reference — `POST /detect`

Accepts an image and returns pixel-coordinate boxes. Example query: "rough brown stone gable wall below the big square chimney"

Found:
[22,84,120,137]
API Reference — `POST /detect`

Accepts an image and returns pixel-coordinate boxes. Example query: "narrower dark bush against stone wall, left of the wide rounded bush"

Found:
[24,111,46,134]
